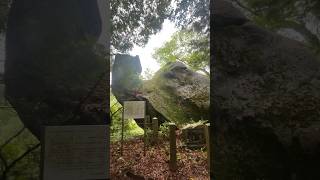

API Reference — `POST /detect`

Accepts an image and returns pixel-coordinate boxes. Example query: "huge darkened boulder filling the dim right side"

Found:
[214,1,320,180]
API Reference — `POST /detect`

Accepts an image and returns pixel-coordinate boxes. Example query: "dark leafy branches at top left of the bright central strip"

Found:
[110,0,171,52]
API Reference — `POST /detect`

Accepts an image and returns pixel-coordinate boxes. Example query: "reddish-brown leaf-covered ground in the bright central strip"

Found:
[110,131,209,180]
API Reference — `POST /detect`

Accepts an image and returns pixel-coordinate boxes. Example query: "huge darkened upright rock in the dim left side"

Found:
[5,0,109,138]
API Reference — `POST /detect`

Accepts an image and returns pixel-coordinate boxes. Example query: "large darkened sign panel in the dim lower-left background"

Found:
[42,125,109,180]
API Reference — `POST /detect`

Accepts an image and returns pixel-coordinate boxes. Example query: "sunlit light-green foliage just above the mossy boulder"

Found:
[153,30,210,75]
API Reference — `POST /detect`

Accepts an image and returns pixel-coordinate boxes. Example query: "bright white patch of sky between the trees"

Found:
[129,20,177,75]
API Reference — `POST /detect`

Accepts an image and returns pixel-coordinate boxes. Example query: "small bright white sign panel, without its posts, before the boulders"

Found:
[123,101,146,119]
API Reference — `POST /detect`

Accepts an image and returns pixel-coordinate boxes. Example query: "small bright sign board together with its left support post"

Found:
[120,101,146,156]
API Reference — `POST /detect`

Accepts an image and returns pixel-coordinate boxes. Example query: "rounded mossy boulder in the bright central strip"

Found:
[143,62,210,124]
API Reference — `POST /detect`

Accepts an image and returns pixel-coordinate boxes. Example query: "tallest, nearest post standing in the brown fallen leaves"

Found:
[169,123,177,171]
